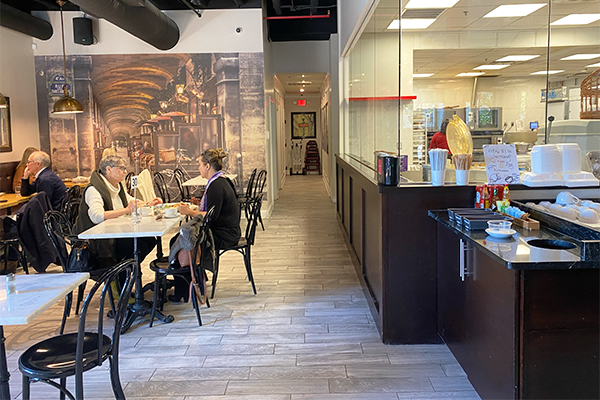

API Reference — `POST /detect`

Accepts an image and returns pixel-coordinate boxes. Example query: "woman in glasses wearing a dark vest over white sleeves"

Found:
[74,156,161,266]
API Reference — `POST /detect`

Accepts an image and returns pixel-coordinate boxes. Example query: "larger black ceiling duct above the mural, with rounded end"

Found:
[70,0,179,50]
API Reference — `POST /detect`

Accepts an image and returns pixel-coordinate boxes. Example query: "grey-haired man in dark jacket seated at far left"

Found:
[21,151,67,210]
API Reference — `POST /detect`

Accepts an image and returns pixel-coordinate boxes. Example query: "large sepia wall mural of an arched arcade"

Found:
[35,53,266,198]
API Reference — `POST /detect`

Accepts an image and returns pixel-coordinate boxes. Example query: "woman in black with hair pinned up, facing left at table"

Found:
[170,149,241,301]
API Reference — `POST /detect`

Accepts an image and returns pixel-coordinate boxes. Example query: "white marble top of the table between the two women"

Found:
[78,215,182,239]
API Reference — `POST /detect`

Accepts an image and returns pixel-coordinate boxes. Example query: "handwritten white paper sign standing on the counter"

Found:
[483,144,521,185]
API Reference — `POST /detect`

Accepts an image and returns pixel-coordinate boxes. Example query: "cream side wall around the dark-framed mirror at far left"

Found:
[0,27,40,162]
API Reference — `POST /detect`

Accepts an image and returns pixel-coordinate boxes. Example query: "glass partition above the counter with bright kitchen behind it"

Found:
[344,0,600,181]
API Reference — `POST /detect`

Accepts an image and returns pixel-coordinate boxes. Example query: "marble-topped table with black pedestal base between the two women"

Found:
[78,215,183,333]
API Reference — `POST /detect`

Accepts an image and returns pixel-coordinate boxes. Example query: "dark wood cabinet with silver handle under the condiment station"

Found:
[437,219,600,399]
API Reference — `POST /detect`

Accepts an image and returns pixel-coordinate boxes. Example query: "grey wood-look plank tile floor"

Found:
[5,175,479,400]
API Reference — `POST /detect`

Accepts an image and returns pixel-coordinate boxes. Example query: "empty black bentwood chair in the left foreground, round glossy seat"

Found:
[19,259,135,400]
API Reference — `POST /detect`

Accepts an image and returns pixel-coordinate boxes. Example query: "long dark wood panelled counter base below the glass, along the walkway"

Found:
[336,157,475,344]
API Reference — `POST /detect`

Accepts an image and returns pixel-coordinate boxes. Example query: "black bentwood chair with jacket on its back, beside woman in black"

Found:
[150,206,216,327]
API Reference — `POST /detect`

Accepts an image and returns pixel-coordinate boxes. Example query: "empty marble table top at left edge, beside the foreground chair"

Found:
[0,272,90,325]
